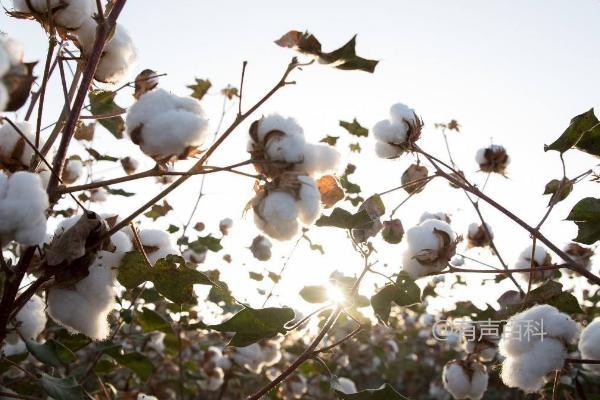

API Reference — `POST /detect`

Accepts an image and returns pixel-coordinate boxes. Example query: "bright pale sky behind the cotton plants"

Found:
[0,0,600,318]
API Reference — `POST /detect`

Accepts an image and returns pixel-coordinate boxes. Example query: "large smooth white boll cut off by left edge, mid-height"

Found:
[0,171,48,246]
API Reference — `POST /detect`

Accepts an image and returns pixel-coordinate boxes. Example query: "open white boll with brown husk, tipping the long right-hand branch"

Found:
[373,103,423,158]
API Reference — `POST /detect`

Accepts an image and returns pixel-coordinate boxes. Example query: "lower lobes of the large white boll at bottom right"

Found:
[500,338,566,393]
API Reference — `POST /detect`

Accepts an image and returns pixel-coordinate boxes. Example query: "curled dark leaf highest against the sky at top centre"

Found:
[275,31,379,73]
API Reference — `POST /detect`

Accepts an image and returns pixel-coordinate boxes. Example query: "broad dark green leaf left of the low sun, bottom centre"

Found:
[208,307,295,347]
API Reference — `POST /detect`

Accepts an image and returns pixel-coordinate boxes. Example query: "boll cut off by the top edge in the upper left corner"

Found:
[13,0,95,30]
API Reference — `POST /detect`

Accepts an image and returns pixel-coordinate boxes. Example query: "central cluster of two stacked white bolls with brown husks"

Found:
[248,114,340,240]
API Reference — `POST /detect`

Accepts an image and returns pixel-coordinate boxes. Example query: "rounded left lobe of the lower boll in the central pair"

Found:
[254,192,300,240]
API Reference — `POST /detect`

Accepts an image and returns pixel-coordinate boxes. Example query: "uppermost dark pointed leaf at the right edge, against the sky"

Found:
[544,108,600,156]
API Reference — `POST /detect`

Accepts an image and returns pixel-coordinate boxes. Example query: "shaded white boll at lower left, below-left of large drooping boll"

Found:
[6,295,47,346]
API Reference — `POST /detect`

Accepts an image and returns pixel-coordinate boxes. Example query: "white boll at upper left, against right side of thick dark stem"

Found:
[94,24,137,83]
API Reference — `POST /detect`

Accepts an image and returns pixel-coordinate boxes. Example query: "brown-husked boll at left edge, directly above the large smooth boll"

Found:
[0,122,35,169]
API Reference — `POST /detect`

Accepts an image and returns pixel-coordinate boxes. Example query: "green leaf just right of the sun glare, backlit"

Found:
[371,273,421,323]
